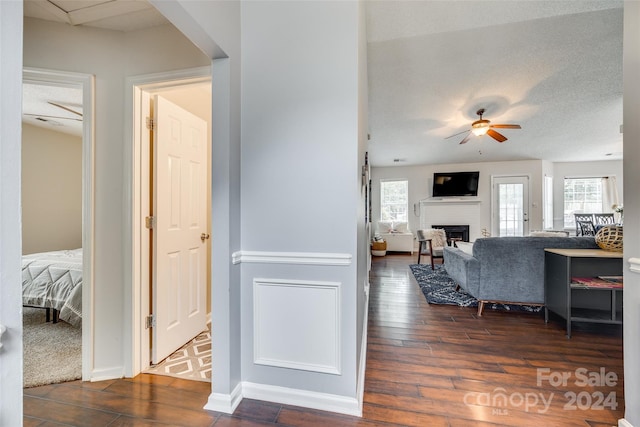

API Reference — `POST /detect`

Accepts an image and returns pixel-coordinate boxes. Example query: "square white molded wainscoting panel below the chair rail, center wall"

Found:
[253,279,341,374]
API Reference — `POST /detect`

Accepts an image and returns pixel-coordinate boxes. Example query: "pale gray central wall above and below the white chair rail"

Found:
[241,2,364,404]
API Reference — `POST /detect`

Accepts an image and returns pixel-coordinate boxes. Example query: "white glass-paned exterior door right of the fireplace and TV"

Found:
[491,176,529,237]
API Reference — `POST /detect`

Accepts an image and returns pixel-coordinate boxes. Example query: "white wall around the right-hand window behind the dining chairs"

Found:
[553,160,624,232]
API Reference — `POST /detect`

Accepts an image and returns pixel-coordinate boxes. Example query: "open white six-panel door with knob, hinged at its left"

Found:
[151,95,208,364]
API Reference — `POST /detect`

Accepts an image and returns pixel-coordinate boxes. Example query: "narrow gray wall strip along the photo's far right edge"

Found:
[623,1,640,426]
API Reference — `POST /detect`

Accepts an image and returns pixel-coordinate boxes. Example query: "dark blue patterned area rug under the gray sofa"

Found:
[409,264,542,313]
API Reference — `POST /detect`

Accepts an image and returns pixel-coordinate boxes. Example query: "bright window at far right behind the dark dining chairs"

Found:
[564,178,602,228]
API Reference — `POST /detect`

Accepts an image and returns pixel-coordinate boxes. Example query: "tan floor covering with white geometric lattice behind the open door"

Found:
[146,326,211,382]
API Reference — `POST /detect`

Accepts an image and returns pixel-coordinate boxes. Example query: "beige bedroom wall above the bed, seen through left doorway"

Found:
[22,124,82,254]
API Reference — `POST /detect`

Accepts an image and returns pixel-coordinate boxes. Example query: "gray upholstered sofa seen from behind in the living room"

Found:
[444,237,598,316]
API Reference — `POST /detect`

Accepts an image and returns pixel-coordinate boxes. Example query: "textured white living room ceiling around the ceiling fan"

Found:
[367,1,623,166]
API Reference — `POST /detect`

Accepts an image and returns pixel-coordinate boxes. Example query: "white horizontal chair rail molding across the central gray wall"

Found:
[231,251,353,266]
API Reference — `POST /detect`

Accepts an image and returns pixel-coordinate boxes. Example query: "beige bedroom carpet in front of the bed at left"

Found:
[22,307,82,388]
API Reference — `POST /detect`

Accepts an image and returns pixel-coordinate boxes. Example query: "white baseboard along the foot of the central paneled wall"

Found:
[242,382,362,417]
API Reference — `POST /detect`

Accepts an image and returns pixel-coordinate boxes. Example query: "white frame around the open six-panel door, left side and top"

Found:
[124,67,212,377]
